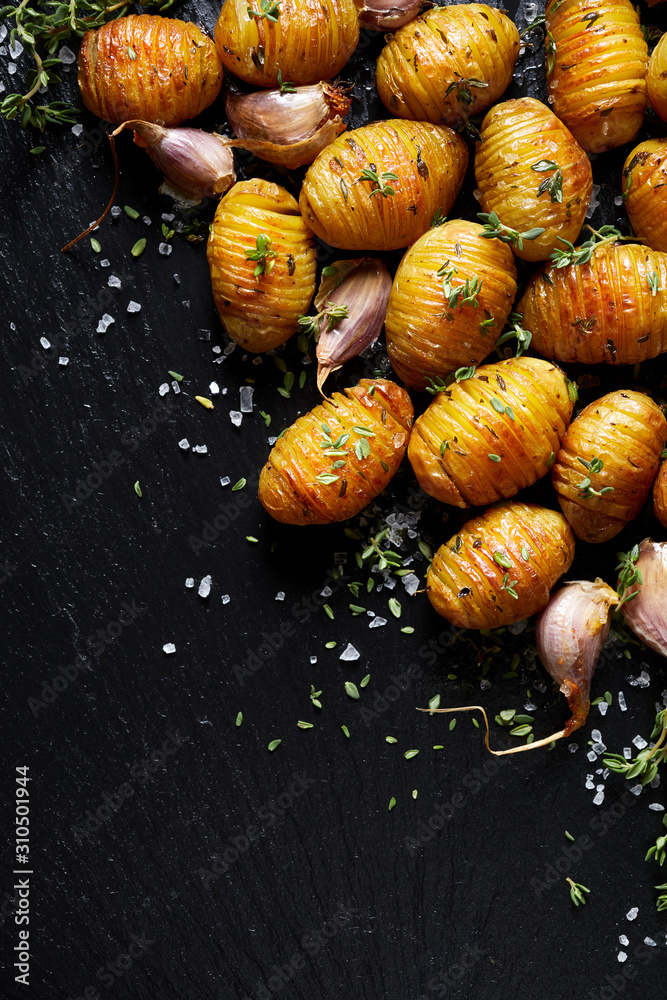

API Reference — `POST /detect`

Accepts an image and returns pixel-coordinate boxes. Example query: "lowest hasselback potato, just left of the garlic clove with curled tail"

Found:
[426,503,574,628]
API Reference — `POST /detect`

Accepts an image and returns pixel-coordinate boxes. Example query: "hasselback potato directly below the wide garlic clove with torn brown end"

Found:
[299,121,468,251]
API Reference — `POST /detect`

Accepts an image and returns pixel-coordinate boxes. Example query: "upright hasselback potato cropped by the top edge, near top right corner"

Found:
[545,0,648,153]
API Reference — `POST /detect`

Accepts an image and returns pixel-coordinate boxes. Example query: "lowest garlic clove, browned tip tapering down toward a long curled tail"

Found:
[535,578,619,736]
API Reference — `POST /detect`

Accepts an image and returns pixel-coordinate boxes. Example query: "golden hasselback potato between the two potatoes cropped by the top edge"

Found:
[376,3,519,125]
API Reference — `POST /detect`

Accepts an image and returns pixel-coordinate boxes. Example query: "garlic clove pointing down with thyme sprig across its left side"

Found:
[315,257,391,392]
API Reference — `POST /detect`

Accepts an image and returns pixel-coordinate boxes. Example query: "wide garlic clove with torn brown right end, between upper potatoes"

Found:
[225,81,352,170]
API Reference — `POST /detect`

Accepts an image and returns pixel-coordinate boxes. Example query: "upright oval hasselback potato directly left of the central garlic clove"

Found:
[207,180,316,353]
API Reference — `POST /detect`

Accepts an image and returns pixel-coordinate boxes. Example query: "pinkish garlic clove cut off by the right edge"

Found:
[621,538,667,656]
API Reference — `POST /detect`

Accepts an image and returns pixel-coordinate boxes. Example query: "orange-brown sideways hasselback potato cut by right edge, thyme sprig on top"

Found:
[517,243,667,365]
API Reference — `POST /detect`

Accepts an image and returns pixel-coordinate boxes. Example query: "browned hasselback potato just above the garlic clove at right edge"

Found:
[552,389,667,542]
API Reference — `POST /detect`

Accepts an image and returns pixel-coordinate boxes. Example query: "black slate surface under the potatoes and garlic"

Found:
[0,3,667,1000]
